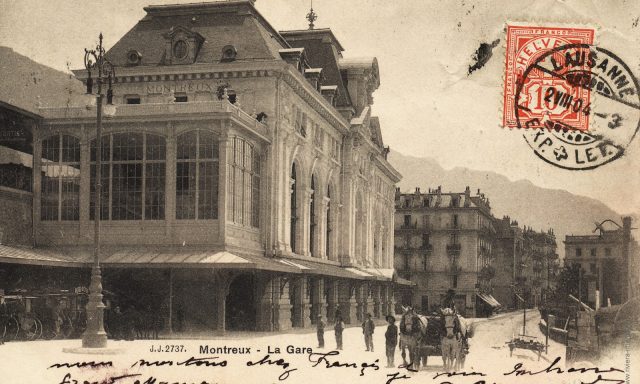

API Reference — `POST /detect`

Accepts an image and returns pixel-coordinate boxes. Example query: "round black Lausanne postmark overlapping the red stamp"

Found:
[513,44,640,170]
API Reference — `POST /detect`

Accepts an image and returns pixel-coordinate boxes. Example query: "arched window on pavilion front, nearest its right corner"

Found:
[176,131,218,220]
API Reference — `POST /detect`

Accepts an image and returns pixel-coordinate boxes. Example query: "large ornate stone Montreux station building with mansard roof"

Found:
[0,0,403,331]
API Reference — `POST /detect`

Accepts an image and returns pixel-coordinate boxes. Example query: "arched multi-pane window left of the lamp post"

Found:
[40,135,80,221]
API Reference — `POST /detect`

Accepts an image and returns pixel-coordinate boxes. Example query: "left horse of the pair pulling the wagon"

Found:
[400,307,428,371]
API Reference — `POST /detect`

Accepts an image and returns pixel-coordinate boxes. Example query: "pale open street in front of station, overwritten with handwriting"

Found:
[0,310,636,384]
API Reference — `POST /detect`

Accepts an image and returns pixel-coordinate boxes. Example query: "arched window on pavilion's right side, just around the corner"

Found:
[228,137,260,228]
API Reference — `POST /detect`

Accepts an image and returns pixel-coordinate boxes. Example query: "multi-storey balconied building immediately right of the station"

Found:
[395,187,495,317]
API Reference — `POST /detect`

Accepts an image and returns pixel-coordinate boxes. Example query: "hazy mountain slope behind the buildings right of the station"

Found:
[388,151,620,257]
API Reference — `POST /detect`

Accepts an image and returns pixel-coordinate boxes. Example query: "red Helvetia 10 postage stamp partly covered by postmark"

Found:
[502,25,594,131]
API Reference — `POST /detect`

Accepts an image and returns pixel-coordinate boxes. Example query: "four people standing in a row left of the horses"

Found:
[316,313,398,368]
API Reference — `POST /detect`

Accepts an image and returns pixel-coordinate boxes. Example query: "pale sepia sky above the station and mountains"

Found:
[0,0,640,214]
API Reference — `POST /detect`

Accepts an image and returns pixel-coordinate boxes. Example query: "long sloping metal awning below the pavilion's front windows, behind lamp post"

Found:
[0,245,300,273]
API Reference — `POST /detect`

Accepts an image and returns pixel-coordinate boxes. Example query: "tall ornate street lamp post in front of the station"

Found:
[82,33,115,348]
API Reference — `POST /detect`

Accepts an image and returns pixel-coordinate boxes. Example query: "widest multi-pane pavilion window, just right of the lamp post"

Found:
[90,132,166,220]
